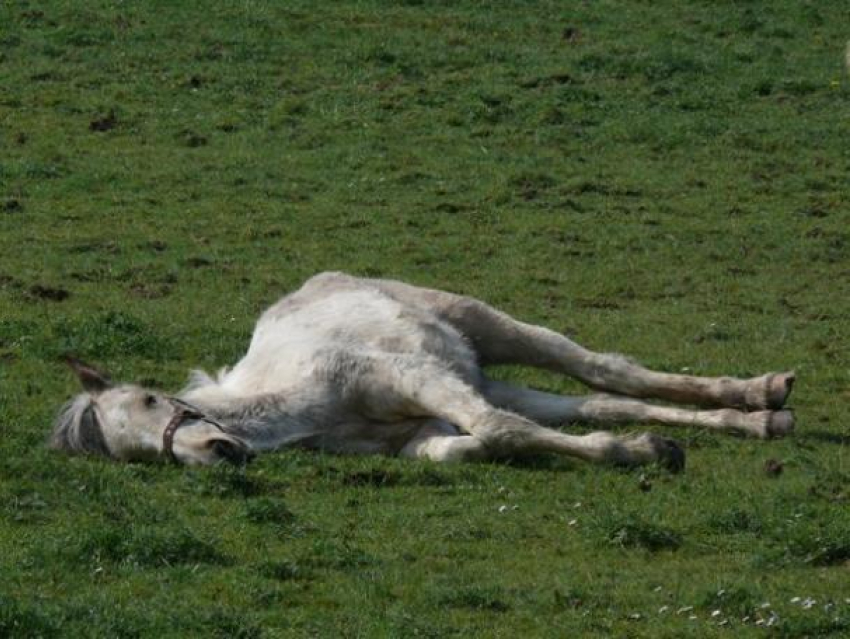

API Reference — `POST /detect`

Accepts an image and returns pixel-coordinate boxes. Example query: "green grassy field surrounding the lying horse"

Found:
[0,0,850,637]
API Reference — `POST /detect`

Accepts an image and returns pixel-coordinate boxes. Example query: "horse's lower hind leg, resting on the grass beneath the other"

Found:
[484,381,794,439]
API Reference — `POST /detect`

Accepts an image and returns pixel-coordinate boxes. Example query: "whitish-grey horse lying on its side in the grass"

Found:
[51,273,794,470]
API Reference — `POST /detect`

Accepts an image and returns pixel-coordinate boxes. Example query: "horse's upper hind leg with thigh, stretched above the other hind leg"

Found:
[373,280,794,410]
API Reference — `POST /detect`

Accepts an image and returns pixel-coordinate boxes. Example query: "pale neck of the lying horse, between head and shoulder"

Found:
[180,387,320,450]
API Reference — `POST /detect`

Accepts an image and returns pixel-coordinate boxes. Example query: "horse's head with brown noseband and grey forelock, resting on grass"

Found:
[50,358,252,464]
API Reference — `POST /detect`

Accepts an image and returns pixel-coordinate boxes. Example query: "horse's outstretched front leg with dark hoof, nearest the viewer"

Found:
[348,354,685,470]
